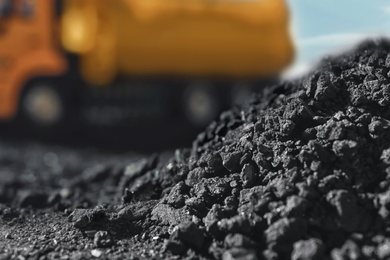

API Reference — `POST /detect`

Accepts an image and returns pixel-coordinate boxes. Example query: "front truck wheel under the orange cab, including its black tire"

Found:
[18,79,77,135]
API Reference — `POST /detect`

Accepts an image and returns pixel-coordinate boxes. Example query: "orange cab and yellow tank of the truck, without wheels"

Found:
[0,0,294,119]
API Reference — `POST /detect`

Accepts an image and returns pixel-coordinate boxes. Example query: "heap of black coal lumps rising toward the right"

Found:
[130,40,390,260]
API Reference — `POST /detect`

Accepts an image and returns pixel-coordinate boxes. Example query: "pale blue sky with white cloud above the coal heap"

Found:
[287,0,390,76]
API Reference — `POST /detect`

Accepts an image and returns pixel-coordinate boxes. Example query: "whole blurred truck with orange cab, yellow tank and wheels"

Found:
[0,0,294,127]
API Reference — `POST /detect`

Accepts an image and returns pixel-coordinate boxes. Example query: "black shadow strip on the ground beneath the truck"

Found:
[0,120,203,154]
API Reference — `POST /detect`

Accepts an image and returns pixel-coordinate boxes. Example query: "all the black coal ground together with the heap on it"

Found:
[0,41,390,260]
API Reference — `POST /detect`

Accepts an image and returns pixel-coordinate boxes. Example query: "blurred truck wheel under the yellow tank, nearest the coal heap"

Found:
[183,82,221,127]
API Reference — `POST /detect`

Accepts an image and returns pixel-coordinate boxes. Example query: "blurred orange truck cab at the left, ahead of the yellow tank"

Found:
[0,0,67,125]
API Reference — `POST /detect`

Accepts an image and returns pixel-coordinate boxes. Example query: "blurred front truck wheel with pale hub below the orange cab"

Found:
[20,82,67,131]
